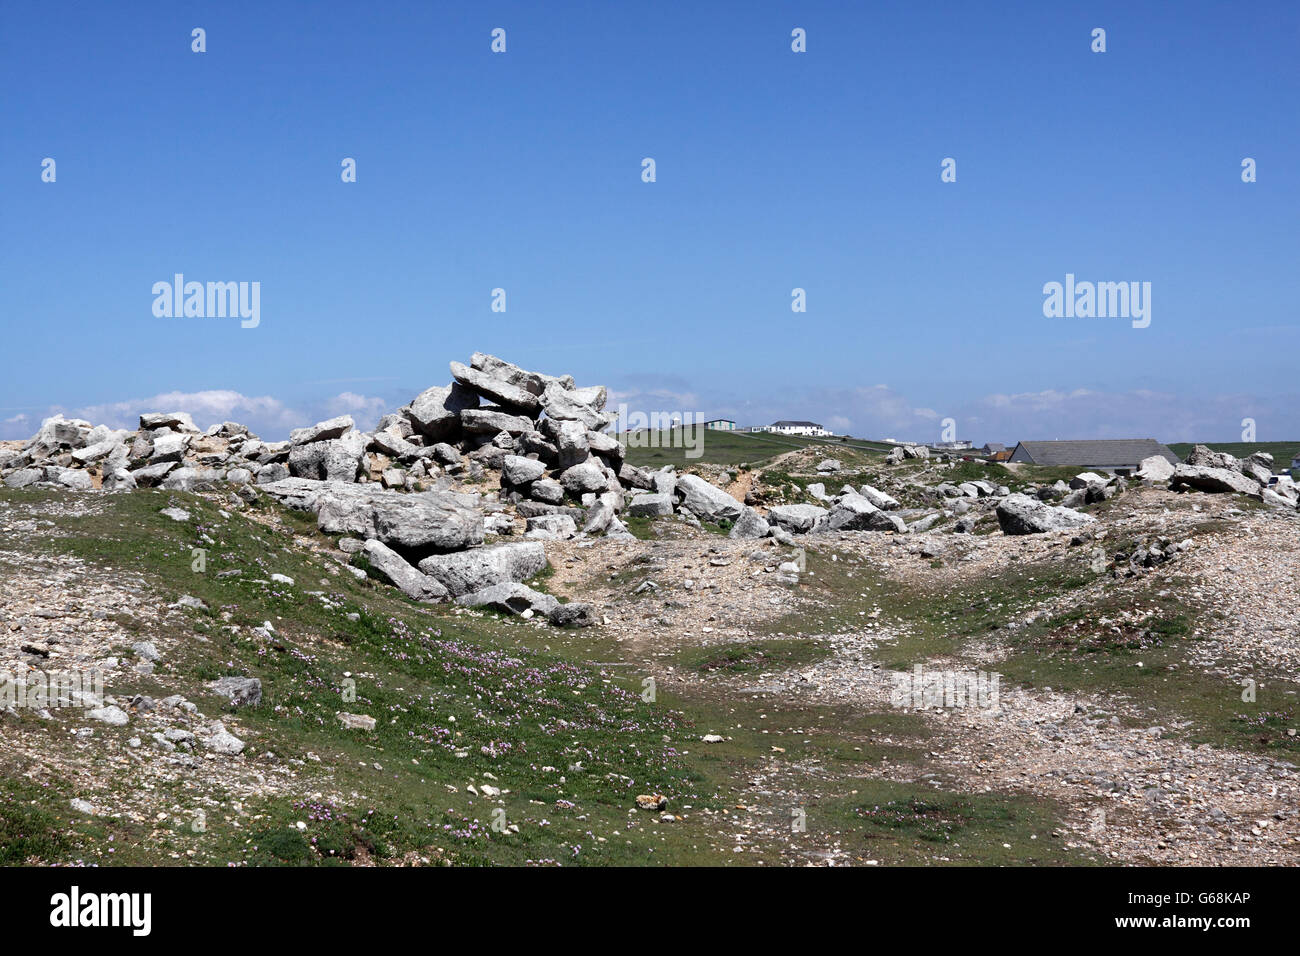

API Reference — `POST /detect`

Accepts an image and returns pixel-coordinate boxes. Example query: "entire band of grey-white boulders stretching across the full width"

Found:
[0,369,1300,623]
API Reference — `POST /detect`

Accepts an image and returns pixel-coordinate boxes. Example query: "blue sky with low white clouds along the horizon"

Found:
[0,1,1300,442]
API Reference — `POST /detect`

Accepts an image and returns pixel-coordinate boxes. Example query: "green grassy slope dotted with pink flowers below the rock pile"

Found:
[0,492,707,864]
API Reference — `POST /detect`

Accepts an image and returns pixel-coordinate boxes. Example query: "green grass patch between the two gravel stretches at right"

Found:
[763,546,1300,758]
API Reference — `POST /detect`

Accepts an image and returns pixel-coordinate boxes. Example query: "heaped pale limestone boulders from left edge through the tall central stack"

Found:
[0,352,771,624]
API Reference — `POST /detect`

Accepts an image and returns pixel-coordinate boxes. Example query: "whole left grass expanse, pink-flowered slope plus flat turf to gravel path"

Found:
[0,490,1107,866]
